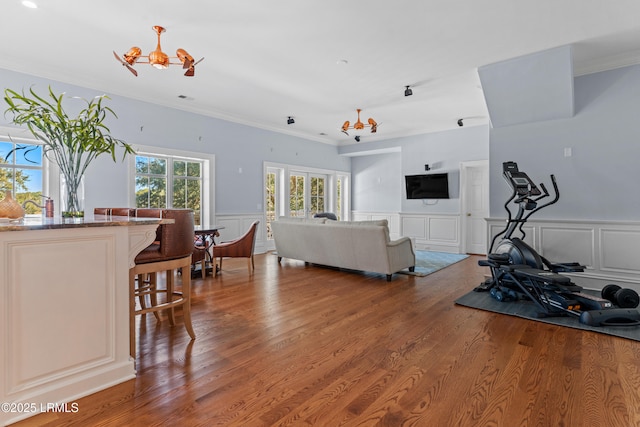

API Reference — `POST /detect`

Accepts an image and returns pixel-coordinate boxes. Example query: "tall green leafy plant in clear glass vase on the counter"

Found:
[4,87,135,216]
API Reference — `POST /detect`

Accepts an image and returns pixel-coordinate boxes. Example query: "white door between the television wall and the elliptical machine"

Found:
[461,161,489,255]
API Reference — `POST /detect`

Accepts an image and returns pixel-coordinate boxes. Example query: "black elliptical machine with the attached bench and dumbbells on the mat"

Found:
[474,162,640,326]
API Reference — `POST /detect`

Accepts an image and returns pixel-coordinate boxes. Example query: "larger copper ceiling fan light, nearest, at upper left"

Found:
[113,25,204,77]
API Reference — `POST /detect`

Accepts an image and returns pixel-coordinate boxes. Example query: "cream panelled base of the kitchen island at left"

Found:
[0,223,157,425]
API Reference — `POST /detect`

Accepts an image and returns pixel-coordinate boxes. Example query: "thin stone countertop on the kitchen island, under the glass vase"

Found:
[0,215,168,232]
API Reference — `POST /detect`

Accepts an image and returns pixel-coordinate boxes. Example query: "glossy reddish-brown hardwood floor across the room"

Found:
[16,254,640,426]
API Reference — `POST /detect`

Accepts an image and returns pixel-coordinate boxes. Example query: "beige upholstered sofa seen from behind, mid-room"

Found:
[271,217,416,281]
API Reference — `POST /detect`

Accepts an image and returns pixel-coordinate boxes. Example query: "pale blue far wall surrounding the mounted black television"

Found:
[348,126,489,214]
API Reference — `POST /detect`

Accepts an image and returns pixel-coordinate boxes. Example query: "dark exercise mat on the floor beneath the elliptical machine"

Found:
[455,290,640,341]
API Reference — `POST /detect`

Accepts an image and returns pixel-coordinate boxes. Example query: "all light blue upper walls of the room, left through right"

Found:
[0,60,640,221]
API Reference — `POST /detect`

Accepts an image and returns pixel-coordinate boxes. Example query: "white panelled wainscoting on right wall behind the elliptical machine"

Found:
[487,218,640,291]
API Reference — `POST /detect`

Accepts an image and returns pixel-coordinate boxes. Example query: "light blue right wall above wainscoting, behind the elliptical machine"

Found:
[490,66,640,221]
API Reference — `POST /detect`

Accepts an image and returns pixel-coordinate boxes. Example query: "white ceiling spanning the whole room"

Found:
[0,0,640,145]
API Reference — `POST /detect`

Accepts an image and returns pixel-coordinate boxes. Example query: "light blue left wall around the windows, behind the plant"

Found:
[0,69,351,214]
